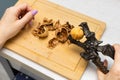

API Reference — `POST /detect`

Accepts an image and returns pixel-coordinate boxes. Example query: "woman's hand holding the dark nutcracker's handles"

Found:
[98,44,120,80]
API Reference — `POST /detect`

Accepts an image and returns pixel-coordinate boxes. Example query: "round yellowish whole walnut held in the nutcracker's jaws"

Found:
[70,27,84,40]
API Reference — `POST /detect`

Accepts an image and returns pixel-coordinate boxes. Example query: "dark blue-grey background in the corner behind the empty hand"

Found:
[0,0,18,18]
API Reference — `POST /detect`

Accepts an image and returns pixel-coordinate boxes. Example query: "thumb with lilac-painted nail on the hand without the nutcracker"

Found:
[19,10,38,27]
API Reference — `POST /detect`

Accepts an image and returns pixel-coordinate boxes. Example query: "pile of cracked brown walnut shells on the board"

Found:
[32,18,74,48]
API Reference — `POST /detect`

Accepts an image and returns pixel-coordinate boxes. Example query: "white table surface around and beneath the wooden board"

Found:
[2,0,120,80]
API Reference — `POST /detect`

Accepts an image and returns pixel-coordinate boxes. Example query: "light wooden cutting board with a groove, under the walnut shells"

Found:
[4,0,105,80]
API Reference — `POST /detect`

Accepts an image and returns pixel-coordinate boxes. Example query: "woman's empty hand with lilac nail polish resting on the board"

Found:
[0,4,37,47]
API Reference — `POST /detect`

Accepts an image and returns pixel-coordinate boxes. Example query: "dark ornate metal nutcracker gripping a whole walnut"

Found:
[68,22,115,74]
